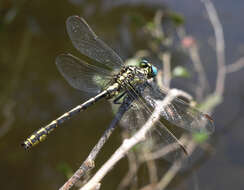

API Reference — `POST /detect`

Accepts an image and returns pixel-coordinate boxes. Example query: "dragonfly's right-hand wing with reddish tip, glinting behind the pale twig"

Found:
[143,85,214,134]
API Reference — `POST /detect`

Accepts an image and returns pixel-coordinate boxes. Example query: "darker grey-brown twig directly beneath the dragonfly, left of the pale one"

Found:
[60,96,133,190]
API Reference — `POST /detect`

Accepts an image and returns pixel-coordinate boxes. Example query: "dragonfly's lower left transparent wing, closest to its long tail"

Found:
[56,54,111,93]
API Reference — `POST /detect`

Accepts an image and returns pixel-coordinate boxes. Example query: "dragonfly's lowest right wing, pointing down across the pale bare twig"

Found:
[115,84,186,162]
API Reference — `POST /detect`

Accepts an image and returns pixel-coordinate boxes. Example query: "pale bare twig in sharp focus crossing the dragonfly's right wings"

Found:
[80,89,192,190]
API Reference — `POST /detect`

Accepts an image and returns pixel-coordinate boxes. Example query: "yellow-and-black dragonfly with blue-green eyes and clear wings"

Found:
[22,16,214,152]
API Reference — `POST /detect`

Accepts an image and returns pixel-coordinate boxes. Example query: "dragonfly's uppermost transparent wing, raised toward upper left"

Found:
[66,16,123,71]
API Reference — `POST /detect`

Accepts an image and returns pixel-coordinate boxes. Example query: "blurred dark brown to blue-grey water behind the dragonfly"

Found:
[0,0,244,190]
